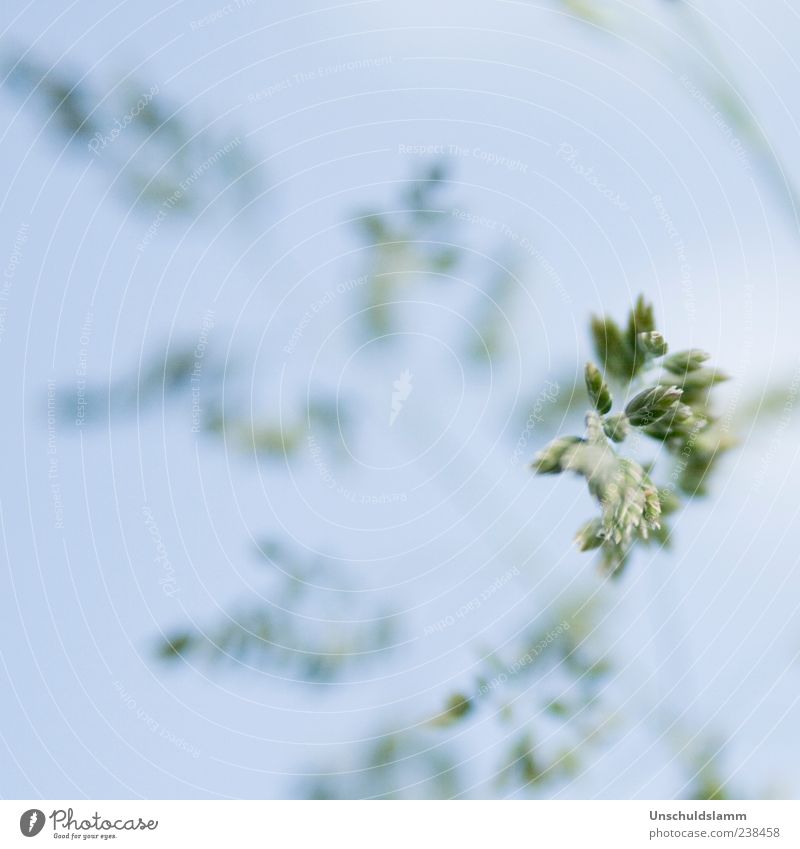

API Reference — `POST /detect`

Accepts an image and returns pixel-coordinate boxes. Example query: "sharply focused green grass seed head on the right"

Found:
[531,296,734,575]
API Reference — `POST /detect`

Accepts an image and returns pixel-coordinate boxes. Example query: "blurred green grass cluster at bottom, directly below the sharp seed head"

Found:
[306,606,615,798]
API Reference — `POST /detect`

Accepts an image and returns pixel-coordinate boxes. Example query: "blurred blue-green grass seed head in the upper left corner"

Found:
[0,50,260,215]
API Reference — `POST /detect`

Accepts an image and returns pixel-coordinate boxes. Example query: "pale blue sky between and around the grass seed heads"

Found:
[0,0,800,798]
